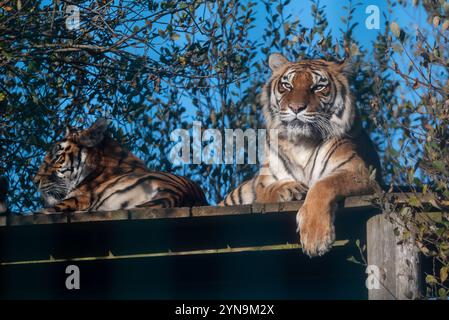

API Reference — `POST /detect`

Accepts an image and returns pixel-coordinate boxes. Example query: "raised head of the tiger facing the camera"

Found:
[262,53,356,140]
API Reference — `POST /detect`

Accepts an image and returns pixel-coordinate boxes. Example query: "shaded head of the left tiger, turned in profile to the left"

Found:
[33,119,108,207]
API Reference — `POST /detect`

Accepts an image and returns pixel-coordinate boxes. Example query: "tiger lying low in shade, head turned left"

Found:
[34,119,207,213]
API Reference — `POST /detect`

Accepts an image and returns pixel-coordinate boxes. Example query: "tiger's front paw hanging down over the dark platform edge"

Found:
[296,200,336,257]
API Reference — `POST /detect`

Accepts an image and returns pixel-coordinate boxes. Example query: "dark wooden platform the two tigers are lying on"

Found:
[0,195,438,299]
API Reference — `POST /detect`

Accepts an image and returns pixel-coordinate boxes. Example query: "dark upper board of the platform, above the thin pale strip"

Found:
[0,208,378,262]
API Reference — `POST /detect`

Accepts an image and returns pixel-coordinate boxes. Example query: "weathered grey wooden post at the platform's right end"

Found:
[367,214,421,300]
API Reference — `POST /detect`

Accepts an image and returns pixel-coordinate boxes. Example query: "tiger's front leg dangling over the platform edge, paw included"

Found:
[296,170,375,257]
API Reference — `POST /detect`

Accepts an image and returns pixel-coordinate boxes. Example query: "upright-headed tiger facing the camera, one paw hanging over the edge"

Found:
[221,54,381,256]
